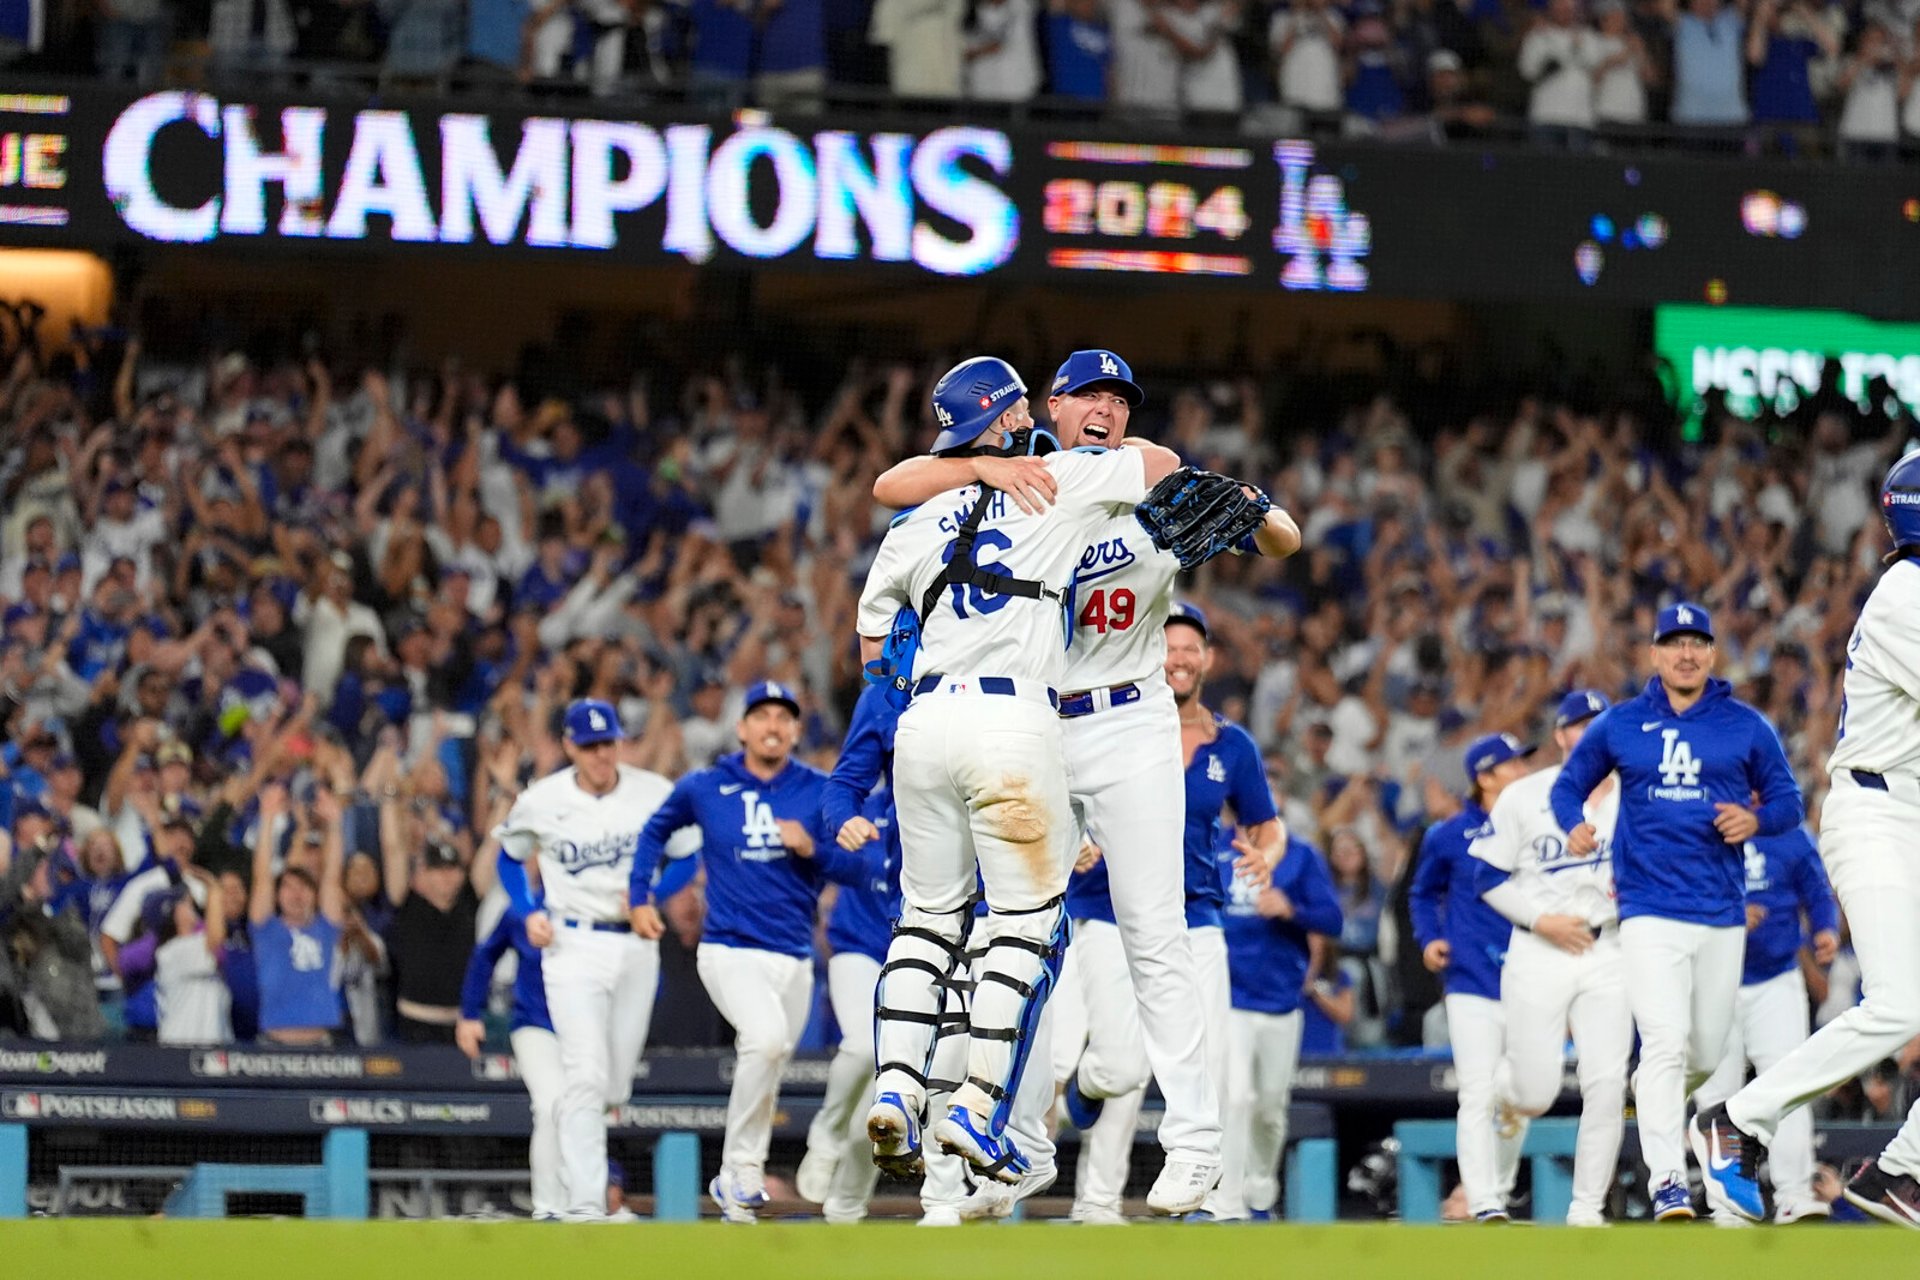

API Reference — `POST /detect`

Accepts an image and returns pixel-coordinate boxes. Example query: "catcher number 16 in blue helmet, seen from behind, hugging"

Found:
[858,357,1179,1184]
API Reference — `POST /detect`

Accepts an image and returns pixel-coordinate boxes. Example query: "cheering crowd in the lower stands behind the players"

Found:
[0,314,1912,1111]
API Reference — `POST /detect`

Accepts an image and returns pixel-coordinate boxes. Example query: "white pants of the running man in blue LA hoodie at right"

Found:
[1620,915,1747,1186]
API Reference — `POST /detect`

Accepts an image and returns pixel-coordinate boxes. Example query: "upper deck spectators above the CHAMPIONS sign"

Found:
[11,0,1920,161]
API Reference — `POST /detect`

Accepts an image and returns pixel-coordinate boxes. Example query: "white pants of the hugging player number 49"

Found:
[1062,676,1221,1163]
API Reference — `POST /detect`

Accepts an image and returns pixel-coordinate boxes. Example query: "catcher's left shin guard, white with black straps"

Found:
[874,906,973,1107]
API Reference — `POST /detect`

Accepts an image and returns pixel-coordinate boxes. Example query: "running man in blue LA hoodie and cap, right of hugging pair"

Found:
[1551,604,1805,1222]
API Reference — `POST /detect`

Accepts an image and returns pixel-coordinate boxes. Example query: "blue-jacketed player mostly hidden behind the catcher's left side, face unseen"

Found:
[793,685,900,1222]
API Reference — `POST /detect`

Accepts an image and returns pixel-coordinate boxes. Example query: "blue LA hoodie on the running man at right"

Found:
[1551,676,1805,927]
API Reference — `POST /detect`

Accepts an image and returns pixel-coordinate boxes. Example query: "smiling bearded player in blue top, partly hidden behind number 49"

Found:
[1056,603,1283,1224]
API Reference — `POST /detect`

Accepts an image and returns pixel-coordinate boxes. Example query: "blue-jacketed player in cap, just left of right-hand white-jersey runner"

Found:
[1407,733,1543,1222]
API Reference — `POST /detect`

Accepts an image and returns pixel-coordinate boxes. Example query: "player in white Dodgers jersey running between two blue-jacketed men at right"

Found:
[1469,689,1634,1226]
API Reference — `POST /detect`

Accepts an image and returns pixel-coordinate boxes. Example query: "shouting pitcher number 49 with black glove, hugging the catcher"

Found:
[874,351,1300,1217]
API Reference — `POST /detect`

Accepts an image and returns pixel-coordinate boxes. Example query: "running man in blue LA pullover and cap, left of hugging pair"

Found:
[628,681,877,1222]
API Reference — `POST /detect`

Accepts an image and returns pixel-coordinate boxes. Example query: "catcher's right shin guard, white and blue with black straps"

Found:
[954,898,1068,1134]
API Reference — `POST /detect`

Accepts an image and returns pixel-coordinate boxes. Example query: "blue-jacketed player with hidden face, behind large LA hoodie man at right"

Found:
[1693,827,1839,1224]
